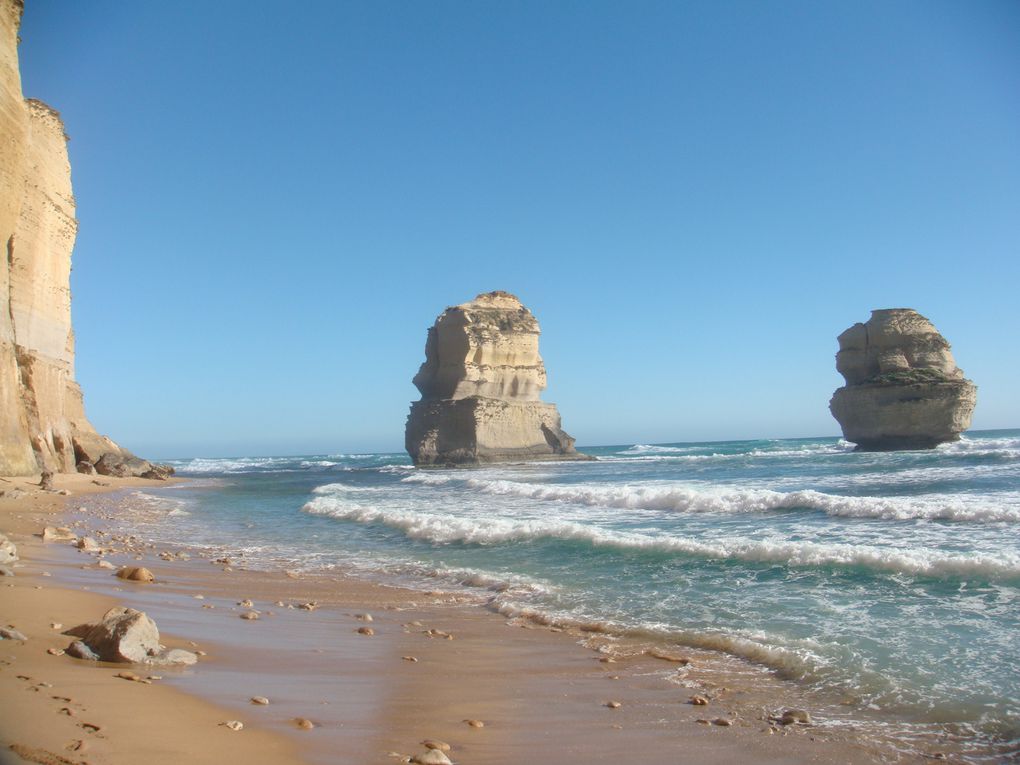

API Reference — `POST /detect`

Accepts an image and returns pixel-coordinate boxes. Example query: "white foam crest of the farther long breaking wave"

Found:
[403,472,1020,522]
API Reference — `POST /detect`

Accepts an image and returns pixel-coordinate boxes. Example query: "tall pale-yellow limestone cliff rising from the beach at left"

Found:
[0,0,167,475]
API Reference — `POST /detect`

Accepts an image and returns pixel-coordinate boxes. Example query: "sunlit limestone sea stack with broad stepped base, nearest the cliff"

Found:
[404,292,590,465]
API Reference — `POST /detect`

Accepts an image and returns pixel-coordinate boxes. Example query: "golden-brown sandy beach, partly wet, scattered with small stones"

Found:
[0,475,911,765]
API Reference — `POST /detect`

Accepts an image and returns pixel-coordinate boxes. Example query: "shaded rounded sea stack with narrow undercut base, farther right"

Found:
[829,308,977,451]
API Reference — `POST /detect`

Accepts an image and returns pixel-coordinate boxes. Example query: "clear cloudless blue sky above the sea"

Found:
[19,0,1020,458]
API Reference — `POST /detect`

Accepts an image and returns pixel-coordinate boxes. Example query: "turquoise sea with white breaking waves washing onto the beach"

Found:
[113,430,1020,757]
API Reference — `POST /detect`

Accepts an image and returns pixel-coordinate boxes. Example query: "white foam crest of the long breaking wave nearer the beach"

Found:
[303,496,1020,580]
